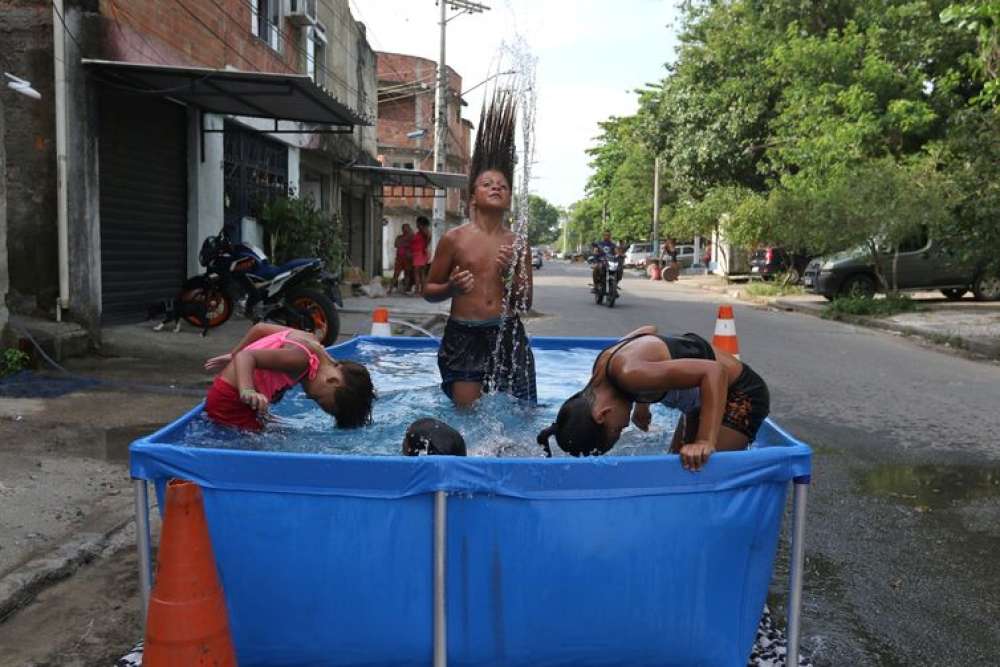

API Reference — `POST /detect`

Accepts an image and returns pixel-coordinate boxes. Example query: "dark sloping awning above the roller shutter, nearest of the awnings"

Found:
[82,59,372,127]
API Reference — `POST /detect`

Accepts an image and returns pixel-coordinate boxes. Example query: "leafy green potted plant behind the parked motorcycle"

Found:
[260,197,344,272]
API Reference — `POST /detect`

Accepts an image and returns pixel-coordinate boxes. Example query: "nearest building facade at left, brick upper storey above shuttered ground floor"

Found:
[0,0,382,340]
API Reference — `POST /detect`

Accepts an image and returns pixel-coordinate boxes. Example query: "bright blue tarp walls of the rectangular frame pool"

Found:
[131,338,811,667]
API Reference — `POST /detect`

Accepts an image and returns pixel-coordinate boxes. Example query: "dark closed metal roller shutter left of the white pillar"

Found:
[99,91,187,323]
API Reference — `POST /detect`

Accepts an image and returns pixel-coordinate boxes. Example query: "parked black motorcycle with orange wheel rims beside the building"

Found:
[180,230,343,345]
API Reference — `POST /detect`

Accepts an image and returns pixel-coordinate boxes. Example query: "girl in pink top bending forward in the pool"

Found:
[205,324,375,431]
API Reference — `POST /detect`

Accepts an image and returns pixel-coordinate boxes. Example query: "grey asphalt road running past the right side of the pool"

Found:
[528,262,1000,666]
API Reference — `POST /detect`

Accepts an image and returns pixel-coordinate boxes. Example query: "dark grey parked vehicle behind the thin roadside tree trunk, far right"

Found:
[803,234,1000,301]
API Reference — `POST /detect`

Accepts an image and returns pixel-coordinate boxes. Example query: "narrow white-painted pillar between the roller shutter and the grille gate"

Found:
[187,110,224,276]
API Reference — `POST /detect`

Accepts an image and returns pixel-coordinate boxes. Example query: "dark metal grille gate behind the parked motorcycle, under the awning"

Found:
[223,123,288,241]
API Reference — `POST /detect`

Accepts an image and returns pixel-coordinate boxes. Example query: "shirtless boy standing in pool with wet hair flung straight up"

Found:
[424,93,537,407]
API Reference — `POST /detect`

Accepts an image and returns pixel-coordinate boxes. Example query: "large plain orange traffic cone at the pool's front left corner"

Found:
[142,479,236,667]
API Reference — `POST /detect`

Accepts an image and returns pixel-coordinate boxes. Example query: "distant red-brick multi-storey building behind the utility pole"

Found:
[378,52,473,271]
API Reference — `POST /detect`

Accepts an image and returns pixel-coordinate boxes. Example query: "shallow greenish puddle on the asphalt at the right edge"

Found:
[860,465,1000,509]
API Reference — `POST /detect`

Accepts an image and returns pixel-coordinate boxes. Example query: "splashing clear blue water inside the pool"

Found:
[181,343,678,457]
